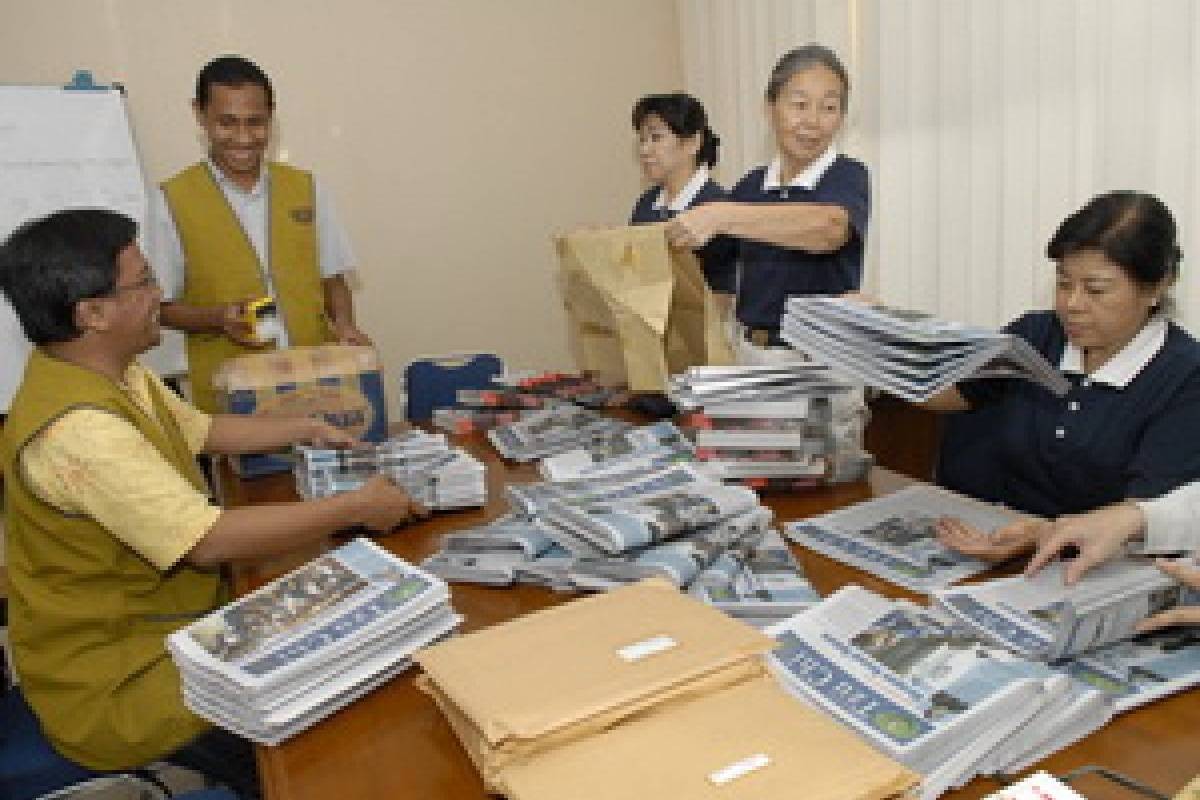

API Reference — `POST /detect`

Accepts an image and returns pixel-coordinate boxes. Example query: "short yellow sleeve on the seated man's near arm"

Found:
[22,409,221,570]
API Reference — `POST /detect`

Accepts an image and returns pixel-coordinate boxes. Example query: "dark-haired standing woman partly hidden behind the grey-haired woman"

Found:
[629,92,736,294]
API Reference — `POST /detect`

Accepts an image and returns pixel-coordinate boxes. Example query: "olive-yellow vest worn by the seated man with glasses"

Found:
[0,350,226,770]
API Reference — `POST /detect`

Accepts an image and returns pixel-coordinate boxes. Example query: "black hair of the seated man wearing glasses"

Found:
[0,209,138,344]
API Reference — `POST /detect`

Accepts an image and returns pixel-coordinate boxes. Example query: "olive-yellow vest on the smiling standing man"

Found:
[162,162,334,414]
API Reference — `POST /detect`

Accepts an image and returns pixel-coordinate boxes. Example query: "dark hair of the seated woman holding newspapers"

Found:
[1046,191,1183,287]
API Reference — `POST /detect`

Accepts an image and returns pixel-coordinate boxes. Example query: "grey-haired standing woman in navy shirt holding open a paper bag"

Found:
[667,44,870,348]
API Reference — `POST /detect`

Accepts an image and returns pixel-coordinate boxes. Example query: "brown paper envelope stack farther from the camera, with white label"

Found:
[415,581,774,747]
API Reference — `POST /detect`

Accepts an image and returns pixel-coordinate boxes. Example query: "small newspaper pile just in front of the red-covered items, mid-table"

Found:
[487,405,631,462]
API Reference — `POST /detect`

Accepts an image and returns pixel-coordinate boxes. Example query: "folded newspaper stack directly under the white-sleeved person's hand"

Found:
[934,558,1186,661]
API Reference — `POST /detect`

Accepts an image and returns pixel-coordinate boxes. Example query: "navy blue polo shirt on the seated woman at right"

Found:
[937,311,1200,517]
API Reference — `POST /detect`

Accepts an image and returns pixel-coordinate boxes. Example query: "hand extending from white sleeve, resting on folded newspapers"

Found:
[1025,503,1146,585]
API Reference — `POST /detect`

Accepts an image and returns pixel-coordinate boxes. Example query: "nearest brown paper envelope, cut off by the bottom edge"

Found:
[503,678,919,800]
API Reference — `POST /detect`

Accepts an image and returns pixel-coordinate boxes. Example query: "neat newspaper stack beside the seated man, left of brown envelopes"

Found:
[167,539,461,745]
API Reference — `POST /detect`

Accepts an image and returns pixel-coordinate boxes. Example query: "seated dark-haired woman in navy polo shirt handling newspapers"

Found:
[926,192,1200,560]
